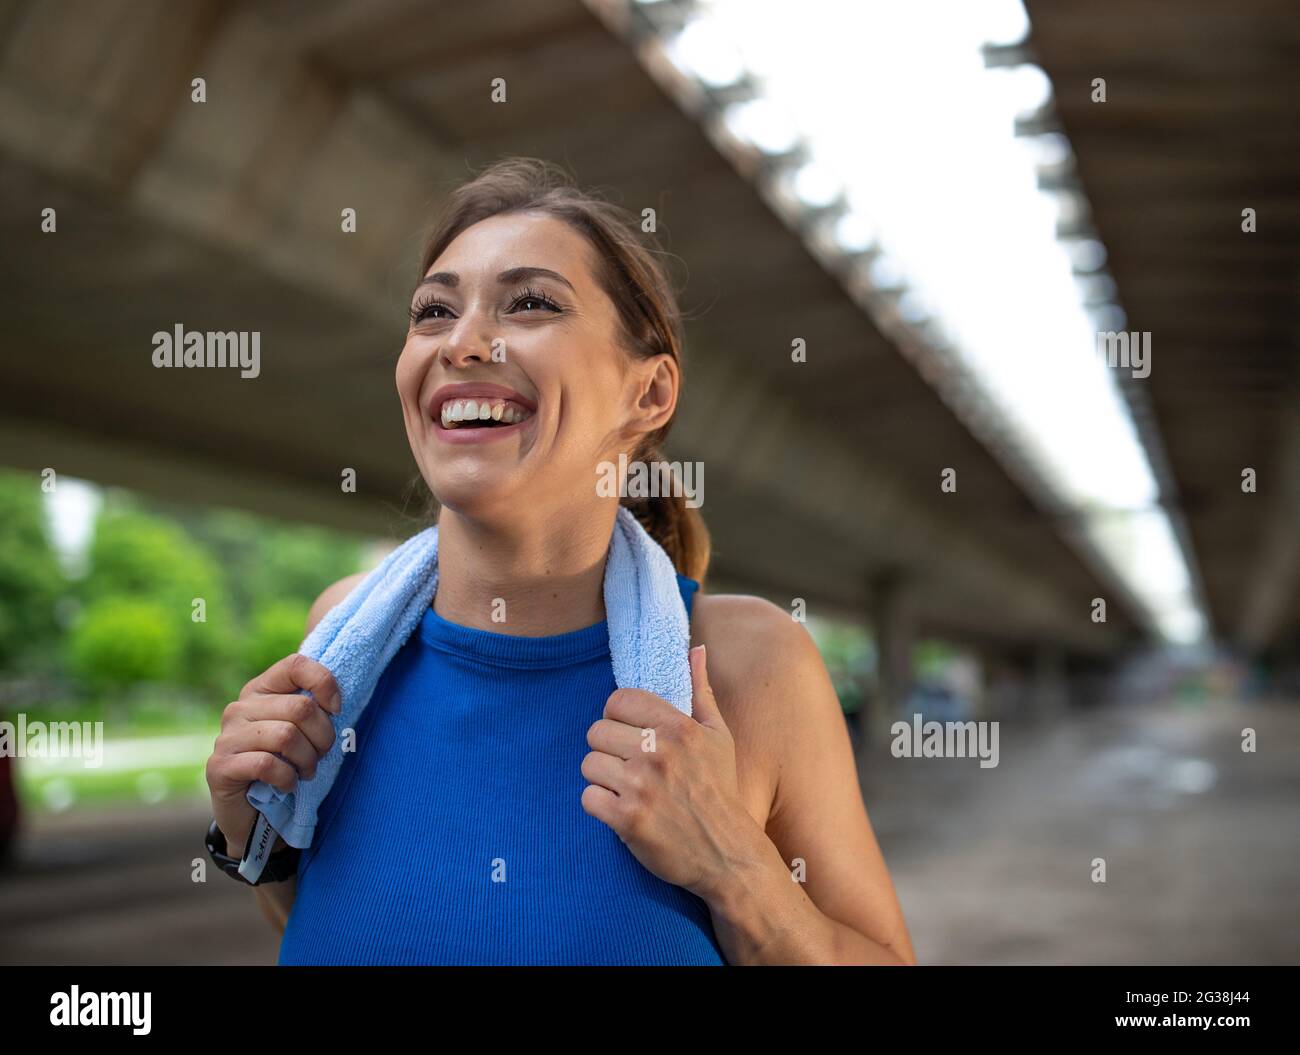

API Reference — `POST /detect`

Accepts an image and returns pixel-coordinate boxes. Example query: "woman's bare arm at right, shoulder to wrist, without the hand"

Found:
[696,595,917,964]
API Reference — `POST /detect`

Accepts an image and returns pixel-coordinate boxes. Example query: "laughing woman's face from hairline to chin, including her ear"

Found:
[397,213,677,520]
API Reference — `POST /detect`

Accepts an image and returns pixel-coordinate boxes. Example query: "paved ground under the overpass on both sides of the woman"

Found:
[0,704,1300,964]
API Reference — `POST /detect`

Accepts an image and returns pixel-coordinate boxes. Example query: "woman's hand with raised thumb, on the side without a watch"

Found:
[582,646,761,899]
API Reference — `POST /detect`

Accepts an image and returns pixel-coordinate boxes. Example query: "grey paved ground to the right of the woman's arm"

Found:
[863,702,1300,964]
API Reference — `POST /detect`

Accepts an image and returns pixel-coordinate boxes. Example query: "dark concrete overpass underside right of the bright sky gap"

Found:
[1027,0,1300,648]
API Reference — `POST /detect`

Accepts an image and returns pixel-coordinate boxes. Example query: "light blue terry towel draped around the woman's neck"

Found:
[239,505,690,881]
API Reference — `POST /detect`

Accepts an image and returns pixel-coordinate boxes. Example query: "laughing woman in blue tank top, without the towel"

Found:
[208,159,915,964]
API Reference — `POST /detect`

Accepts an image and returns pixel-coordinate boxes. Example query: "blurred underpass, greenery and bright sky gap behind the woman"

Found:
[0,0,1300,964]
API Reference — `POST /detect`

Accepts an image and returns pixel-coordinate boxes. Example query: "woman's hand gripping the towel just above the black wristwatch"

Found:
[207,652,342,858]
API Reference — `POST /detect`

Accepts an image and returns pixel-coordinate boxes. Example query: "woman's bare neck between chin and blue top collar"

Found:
[433,503,618,638]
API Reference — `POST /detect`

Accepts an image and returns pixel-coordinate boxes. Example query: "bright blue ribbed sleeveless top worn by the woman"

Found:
[280,576,725,965]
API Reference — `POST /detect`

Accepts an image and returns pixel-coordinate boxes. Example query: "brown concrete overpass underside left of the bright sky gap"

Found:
[0,0,1227,654]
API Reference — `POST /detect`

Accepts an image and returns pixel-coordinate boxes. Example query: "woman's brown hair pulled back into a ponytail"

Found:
[420,157,710,582]
